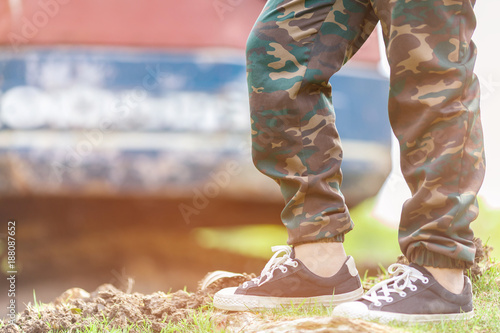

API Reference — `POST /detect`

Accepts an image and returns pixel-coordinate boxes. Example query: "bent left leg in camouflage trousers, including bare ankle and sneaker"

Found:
[214,0,377,310]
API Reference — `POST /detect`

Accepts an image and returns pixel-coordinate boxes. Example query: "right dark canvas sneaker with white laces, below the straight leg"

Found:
[333,264,474,323]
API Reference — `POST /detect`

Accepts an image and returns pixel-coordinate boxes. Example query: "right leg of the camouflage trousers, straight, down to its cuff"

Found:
[374,0,485,268]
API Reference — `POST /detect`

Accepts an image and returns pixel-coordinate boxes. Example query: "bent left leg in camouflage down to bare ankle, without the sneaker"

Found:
[247,0,376,275]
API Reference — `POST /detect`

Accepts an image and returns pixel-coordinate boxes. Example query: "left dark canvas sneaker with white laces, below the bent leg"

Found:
[214,246,363,311]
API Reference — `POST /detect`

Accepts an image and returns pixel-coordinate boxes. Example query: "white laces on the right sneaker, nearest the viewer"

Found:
[363,264,429,306]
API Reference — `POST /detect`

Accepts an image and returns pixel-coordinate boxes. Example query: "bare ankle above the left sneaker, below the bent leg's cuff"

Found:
[294,242,347,277]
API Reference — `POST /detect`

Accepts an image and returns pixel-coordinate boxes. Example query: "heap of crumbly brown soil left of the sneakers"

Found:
[0,274,255,333]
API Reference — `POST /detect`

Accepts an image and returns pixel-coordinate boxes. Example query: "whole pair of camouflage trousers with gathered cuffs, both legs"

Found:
[247,0,484,267]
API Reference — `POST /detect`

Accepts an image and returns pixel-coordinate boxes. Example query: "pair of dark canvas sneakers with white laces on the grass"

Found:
[214,246,474,322]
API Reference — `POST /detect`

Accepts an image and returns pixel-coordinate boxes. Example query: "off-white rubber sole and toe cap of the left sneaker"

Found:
[214,287,363,311]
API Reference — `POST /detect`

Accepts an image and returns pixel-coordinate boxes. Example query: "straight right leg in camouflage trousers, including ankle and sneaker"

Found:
[334,0,484,321]
